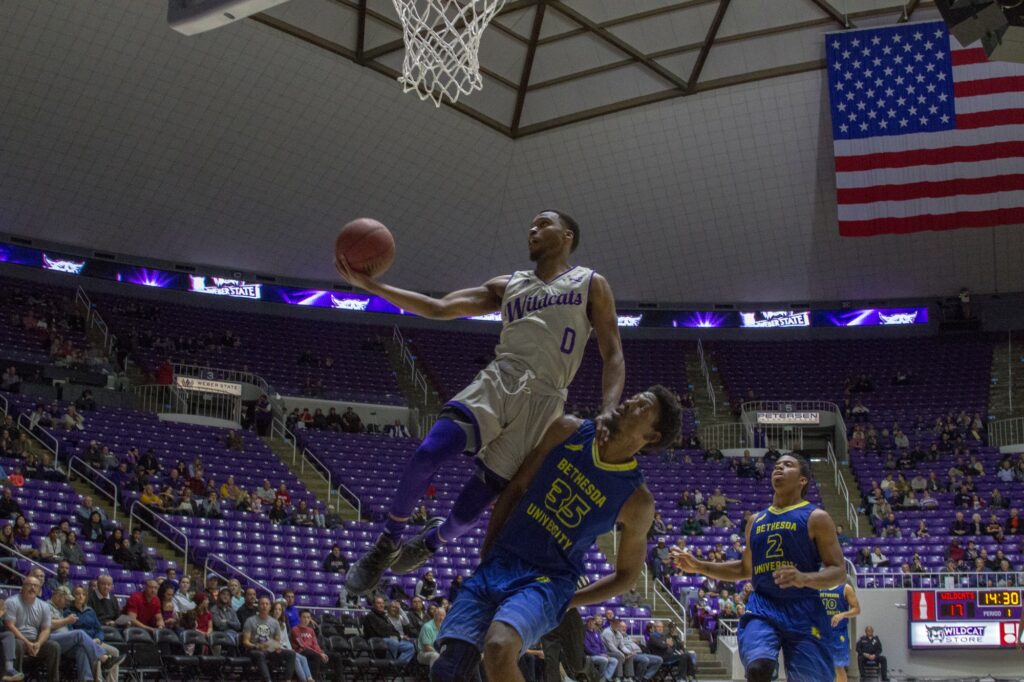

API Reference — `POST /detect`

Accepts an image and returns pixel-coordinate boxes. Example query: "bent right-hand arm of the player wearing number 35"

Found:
[569,485,654,608]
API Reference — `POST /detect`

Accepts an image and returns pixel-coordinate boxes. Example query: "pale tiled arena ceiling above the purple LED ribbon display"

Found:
[0,0,1024,303]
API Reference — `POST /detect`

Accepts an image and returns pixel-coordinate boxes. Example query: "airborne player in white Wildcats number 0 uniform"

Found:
[338,211,626,594]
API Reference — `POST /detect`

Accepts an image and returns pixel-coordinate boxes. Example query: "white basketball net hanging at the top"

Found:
[393,0,505,106]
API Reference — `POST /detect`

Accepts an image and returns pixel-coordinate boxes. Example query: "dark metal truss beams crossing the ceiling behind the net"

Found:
[251,0,934,138]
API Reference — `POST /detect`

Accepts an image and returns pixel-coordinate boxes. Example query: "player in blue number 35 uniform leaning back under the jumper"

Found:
[430,386,680,682]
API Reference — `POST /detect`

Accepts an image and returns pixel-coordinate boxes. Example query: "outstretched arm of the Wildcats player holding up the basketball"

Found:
[337,259,509,319]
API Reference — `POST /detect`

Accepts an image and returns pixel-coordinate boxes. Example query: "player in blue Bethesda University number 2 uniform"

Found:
[672,455,846,682]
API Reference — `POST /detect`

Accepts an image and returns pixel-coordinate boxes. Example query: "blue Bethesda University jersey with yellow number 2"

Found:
[751,501,821,599]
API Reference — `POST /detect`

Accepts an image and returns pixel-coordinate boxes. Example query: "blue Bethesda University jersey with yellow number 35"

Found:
[496,420,643,576]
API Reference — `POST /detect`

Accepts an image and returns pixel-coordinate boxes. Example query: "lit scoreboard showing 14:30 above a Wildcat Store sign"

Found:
[906,590,1021,649]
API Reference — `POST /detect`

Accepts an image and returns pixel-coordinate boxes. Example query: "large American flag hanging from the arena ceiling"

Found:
[825,22,1024,237]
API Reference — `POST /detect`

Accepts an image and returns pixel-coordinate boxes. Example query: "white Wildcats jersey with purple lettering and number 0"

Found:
[495,265,594,390]
